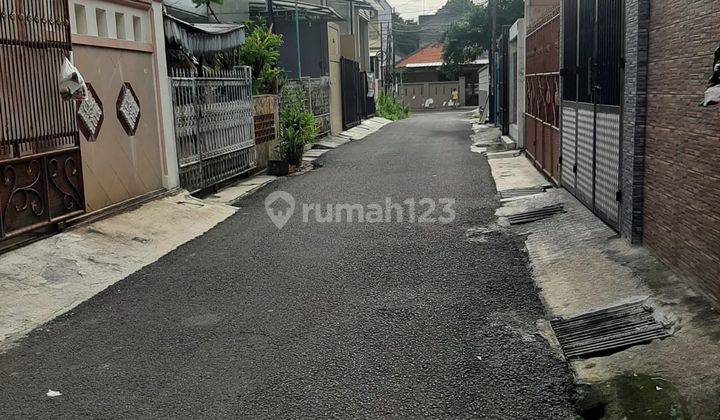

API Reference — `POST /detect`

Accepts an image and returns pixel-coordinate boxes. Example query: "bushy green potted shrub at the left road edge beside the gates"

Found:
[279,84,317,166]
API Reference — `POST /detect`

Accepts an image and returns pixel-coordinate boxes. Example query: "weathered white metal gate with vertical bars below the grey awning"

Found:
[170,67,257,192]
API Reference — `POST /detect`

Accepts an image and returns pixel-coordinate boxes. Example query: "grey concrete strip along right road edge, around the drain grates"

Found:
[478,134,720,418]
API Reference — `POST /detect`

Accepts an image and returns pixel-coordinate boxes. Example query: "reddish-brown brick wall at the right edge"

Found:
[643,0,720,302]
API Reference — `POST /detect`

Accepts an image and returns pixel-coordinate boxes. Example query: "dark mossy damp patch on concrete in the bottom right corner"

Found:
[578,374,690,420]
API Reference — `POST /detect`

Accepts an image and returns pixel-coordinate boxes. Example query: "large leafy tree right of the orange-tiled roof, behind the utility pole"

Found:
[442,0,525,78]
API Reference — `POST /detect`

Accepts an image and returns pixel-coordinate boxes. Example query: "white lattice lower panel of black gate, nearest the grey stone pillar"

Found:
[595,107,620,224]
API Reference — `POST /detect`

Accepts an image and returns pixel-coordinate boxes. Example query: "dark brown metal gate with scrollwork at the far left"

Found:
[0,0,84,245]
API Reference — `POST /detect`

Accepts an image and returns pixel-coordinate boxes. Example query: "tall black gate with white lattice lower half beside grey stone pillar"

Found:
[561,0,624,229]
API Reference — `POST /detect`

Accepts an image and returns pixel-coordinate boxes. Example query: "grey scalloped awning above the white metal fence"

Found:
[164,14,245,56]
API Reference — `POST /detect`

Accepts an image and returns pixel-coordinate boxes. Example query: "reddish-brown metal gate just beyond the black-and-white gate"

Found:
[525,13,560,183]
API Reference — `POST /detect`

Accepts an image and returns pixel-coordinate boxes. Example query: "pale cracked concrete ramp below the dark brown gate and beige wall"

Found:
[0,192,237,351]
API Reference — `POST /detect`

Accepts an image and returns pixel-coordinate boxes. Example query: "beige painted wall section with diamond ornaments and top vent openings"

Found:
[70,0,169,211]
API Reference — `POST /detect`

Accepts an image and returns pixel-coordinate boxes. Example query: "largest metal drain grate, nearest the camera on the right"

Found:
[550,301,670,358]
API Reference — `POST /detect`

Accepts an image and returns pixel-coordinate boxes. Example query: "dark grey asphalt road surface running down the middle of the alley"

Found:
[0,113,573,418]
